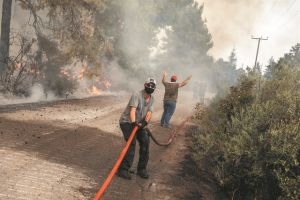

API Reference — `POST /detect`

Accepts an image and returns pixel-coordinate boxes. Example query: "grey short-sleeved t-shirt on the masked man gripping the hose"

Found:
[119,90,154,124]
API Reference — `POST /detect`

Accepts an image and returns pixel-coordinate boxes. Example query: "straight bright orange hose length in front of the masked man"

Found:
[94,126,138,200]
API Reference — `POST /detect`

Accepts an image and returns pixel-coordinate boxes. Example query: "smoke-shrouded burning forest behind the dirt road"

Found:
[0,0,243,96]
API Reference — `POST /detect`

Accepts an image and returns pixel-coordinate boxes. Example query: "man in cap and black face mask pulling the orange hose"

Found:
[117,78,156,180]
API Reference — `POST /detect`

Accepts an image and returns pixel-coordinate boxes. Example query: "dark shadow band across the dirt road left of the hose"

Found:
[0,118,124,198]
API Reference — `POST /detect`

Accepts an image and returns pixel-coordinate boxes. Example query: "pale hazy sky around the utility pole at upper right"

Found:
[197,0,300,67]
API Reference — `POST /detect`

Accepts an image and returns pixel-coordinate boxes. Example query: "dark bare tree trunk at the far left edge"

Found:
[0,0,12,72]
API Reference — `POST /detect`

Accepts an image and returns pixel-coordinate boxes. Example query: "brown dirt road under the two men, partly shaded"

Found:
[0,91,220,200]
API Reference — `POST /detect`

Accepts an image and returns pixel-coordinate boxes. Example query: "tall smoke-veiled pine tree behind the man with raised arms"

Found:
[160,1,213,74]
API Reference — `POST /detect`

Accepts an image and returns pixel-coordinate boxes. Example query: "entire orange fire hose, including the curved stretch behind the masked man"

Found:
[94,118,189,200]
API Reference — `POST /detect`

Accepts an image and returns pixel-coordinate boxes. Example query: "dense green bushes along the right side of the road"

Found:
[193,44,300,200]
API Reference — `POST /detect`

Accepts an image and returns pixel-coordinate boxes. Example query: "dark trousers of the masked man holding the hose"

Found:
[120,123,150,170]
